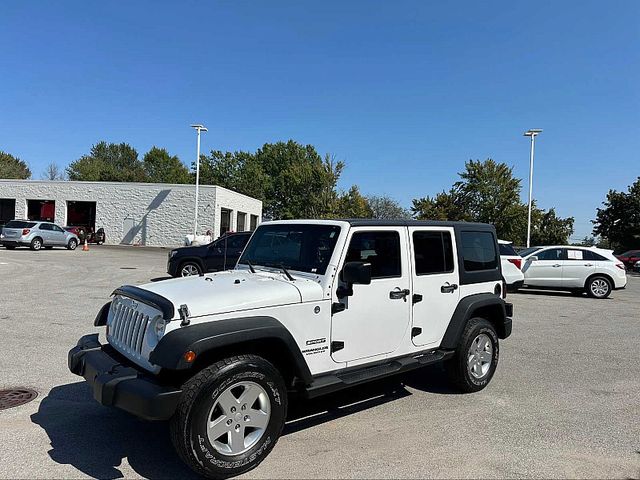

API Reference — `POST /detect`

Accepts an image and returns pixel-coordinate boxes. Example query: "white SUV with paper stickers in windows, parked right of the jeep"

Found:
[521,245,627,298]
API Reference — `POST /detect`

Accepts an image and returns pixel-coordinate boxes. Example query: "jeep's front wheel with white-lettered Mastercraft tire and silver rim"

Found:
[171,355,287,478]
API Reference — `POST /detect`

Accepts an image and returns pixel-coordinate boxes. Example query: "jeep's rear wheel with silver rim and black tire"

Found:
[445,317,500,393]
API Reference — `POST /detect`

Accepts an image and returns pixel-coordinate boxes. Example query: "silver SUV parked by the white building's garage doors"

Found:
[0,220,80,250]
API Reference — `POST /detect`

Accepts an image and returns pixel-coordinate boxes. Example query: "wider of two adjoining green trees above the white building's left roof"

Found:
[67,142,147,182]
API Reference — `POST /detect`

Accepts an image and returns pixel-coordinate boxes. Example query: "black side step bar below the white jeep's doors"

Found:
[305,350,454,398]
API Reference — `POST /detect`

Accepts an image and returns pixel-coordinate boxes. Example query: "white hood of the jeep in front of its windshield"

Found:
[140,270,322,317]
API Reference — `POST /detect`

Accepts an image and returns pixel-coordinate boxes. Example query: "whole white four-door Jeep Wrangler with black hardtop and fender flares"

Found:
[69,220,512,478]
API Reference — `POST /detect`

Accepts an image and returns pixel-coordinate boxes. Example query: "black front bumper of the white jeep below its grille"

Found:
[68,333,182,420]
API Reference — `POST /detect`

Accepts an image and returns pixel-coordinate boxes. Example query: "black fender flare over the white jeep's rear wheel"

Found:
[440,293,511,349]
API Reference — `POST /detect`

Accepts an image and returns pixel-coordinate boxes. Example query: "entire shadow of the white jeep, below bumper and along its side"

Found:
[31,366,453,480]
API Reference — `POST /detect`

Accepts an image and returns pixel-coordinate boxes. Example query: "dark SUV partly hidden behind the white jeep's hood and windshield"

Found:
[167,232,251,277]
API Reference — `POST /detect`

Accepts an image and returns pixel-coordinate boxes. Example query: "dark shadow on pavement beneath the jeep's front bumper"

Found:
[31,382,199,479]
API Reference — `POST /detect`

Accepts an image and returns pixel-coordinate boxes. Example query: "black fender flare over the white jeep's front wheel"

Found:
[149,316,312,383]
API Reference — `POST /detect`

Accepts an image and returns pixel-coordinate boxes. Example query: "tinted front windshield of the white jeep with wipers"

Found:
[238,224,340,275]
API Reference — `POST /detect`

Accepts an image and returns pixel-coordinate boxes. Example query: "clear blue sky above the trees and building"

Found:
[0,0,640,237]
